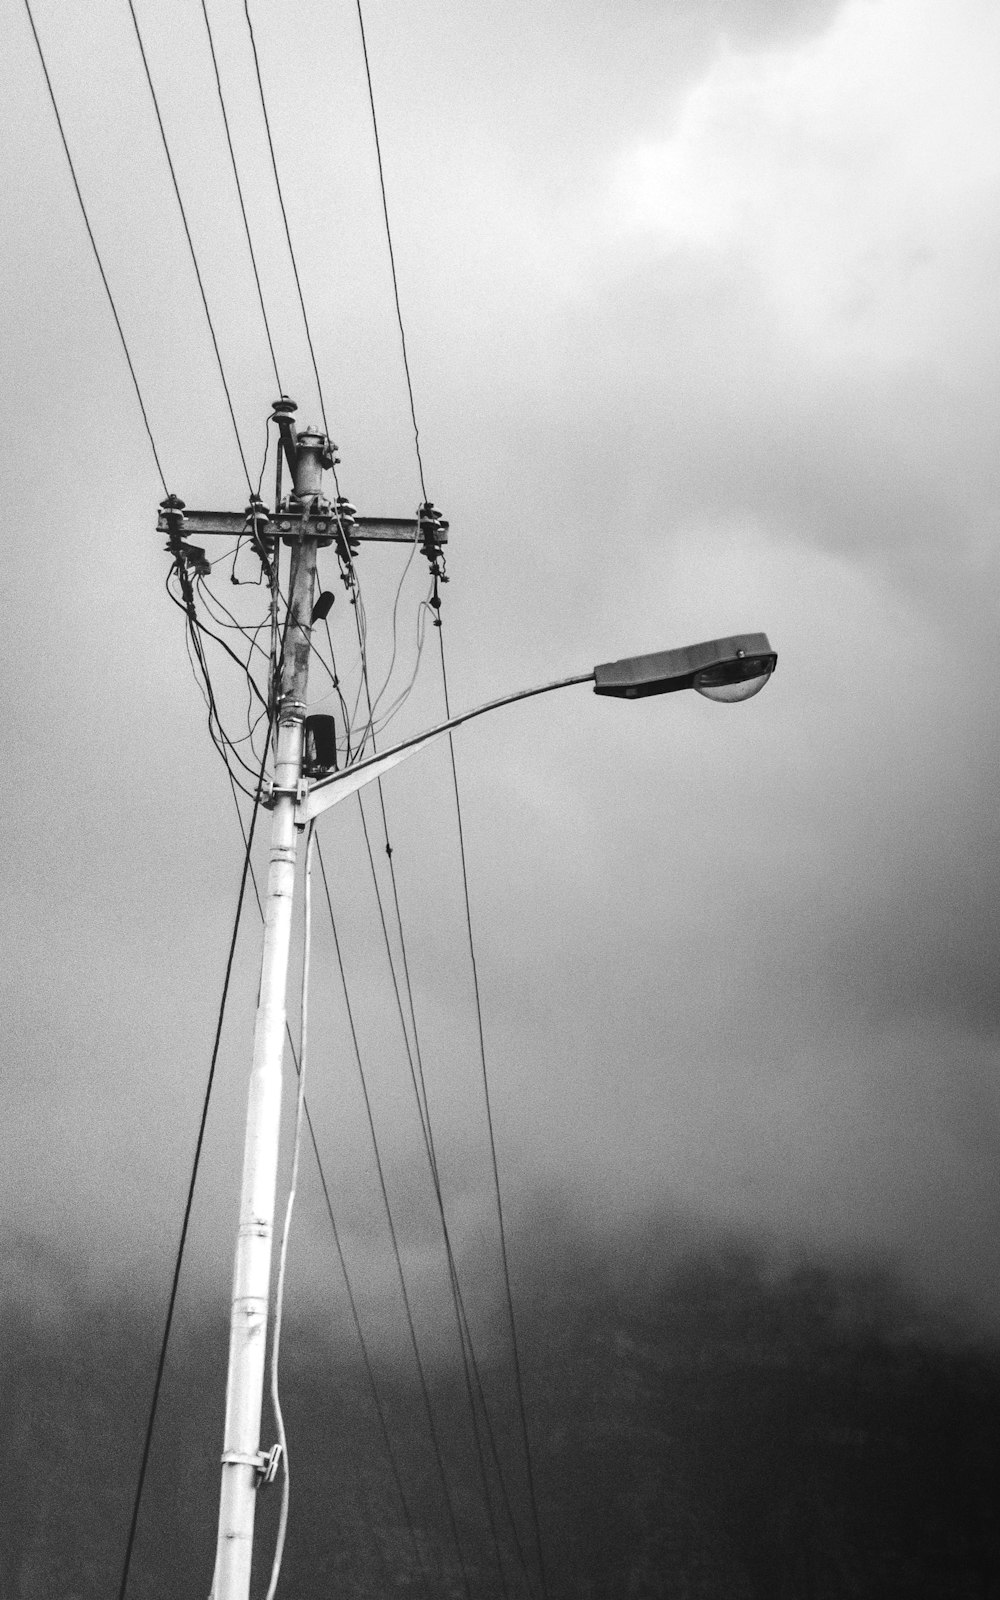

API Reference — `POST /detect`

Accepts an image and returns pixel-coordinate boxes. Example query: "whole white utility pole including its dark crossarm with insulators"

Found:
[158,395,448,1600]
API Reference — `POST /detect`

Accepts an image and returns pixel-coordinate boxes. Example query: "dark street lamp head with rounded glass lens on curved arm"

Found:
[594,634,778,704]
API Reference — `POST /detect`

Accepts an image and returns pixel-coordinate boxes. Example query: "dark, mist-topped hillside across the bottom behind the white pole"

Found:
[0,1234,1000,1600]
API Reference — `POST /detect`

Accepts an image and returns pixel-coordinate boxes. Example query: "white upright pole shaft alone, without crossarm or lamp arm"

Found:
[211,432,326,1600]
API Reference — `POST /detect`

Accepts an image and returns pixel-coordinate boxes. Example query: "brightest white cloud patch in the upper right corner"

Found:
[618,0,1000,371]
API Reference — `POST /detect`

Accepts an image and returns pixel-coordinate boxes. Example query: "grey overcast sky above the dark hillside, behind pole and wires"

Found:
[0,0,1000,1325]
